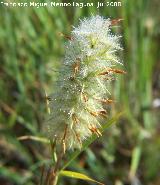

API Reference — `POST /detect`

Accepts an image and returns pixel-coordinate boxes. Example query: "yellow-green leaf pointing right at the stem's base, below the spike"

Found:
[60,170,104,185]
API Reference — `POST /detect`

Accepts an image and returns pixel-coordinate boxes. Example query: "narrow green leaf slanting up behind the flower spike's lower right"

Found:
[61,112,123,170]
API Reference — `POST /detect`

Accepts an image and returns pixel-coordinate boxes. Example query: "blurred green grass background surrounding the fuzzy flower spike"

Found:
[0,0,160,185]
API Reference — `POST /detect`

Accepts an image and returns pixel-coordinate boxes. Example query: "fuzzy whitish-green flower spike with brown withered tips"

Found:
[47,16,125,152]
